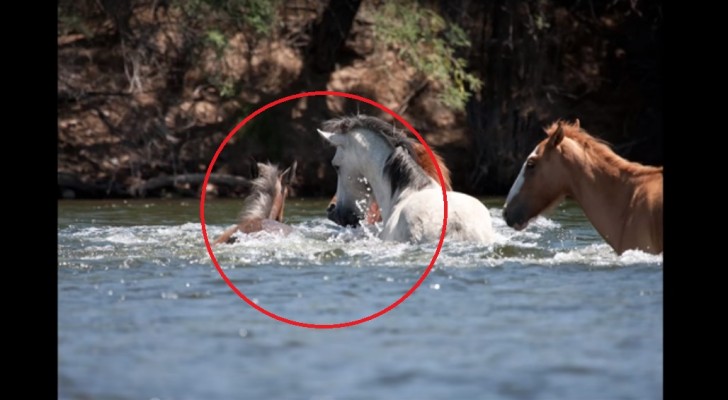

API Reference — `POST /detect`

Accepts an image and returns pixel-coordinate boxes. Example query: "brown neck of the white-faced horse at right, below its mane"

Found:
[569,142,649,249]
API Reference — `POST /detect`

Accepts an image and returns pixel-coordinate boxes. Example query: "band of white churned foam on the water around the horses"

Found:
[59,209,662,269]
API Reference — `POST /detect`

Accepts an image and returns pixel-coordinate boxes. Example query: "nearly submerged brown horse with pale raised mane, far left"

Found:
[213,161,297,245]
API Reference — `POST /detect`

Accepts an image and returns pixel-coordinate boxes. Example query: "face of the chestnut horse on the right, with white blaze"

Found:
[503,127,568,231]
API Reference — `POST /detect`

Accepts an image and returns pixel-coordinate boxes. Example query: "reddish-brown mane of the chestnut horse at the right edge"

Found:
[544,120,662,175]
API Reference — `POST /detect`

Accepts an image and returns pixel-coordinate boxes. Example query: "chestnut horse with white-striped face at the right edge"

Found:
[503,119,663,254]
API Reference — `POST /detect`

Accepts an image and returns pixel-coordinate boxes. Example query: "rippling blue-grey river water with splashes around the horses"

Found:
[58,199,663,400]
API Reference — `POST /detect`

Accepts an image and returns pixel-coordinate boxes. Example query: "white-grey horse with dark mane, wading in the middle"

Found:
[318,115,495,244]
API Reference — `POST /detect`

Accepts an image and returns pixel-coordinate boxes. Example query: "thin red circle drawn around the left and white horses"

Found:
[200,91,447,329]
